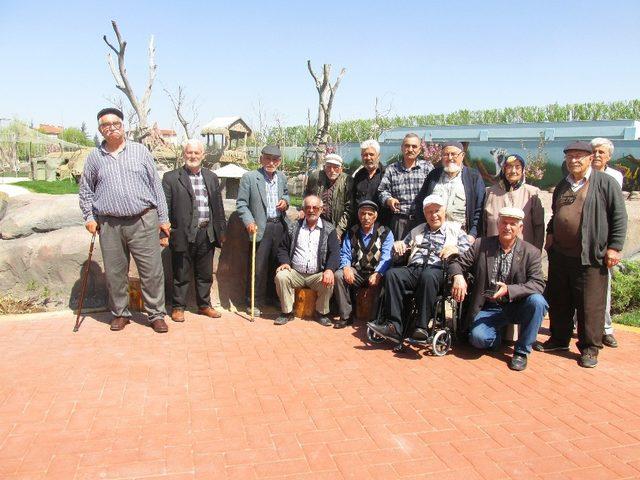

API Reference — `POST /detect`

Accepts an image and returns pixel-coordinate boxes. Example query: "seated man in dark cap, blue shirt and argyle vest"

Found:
[333,200,393,328]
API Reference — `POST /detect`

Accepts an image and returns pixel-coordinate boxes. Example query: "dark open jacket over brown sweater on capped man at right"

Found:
[547,168,627,267]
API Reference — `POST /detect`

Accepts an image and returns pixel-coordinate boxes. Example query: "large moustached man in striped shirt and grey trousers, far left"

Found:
[79,108,170,333]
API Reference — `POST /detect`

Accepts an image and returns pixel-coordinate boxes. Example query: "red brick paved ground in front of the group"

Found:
[0,312,640,480]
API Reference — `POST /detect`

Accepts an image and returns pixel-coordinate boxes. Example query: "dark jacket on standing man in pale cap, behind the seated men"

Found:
[304,170,353,238]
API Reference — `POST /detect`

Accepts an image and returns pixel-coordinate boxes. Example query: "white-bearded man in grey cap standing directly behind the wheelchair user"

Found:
[415,142,485,241]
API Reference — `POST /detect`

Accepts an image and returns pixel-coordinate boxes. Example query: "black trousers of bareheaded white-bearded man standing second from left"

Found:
[171,228,215,309]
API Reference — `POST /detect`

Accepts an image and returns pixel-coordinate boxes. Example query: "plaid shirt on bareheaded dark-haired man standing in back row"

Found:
[378,159,433,215]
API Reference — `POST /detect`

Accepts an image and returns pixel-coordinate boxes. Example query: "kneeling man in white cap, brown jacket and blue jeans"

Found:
[449,207,548,370]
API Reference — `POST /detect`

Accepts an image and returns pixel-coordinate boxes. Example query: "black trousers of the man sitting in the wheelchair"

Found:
[383,265,443,334]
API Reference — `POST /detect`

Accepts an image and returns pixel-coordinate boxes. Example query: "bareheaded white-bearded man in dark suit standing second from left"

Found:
[162,140,227,322]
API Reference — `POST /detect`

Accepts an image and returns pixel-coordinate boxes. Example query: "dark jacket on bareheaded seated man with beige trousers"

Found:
[278,219,340,272]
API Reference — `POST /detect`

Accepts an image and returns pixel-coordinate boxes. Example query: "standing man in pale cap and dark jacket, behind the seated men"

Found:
[300,153,353,239]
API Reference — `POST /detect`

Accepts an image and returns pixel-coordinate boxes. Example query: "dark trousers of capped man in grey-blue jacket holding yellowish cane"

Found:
[246,221,284,307]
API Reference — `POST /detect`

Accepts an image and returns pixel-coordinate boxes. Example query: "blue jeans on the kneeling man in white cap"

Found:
[469,293,549,355]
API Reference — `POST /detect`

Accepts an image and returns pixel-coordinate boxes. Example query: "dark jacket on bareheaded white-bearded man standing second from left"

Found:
[162,167,227,252]
